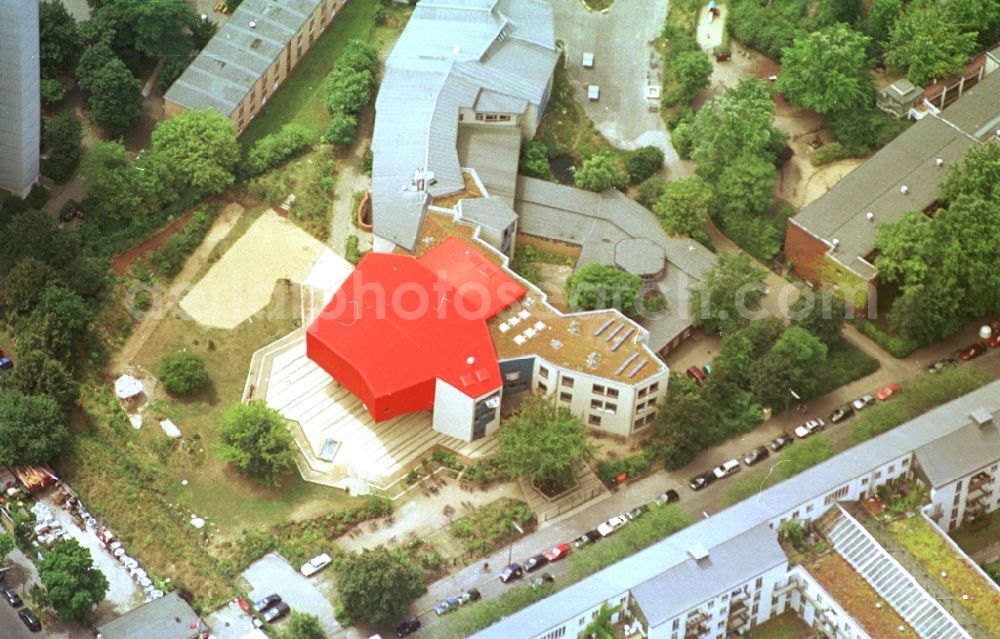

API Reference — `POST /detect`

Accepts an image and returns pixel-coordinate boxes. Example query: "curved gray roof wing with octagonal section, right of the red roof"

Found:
[514,175,715,351]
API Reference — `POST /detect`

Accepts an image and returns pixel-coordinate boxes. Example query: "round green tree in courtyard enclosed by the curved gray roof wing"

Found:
[566,262,662,319]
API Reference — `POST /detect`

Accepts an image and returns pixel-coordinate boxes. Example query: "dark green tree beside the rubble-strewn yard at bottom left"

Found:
[38,539,108,624]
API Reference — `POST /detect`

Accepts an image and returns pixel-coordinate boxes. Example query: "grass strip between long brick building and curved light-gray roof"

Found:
[240,0,380,150]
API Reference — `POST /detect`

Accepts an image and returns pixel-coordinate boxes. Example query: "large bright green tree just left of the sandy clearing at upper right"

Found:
[691,78,775,180]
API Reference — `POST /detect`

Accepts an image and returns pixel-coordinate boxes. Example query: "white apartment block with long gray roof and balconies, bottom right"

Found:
[474,381,1000,639]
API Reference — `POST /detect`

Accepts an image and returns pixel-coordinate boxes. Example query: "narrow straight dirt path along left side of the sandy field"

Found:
[108,203,243,375]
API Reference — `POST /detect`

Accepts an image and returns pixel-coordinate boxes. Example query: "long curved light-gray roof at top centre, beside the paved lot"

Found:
[372,0,558,250]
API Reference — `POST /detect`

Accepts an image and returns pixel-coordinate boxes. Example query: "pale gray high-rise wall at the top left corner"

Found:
[0,0,41,197]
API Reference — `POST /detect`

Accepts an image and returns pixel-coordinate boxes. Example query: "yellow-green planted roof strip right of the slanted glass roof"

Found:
[888,515,1000,637]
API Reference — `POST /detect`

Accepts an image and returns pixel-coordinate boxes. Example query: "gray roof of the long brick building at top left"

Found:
[164,0,322,118]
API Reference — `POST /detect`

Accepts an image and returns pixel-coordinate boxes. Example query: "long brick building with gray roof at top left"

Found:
[164,0,347,135]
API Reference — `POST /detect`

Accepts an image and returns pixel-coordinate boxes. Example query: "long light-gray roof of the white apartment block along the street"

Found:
[473,381,1000,639]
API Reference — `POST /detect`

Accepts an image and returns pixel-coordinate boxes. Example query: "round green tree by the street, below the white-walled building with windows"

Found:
[500,397,594,496]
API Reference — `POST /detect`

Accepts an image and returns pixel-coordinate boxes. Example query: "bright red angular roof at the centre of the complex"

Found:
[306,238,525,420]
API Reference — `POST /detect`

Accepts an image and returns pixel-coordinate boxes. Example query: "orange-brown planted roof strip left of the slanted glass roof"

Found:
[808,553,919,639]
